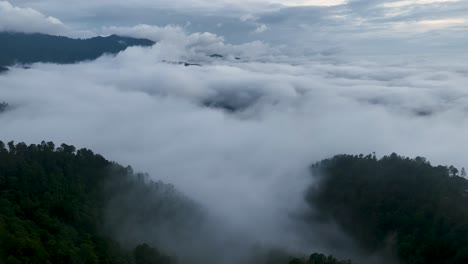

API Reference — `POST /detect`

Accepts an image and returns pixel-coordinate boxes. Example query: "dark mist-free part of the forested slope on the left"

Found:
[0,141,174,264]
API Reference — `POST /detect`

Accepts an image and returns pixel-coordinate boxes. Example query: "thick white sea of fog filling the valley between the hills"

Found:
[0,31,468,262]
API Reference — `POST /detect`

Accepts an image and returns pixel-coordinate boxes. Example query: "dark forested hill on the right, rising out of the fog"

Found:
[307,154,468,264]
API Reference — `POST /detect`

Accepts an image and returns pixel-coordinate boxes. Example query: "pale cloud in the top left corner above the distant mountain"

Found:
[0,1,68,34]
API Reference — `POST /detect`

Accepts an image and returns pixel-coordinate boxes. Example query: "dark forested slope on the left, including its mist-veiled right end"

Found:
[0,141,348,264]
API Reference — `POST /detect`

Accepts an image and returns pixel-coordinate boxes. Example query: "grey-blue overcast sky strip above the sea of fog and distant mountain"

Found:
[0,0,468,55]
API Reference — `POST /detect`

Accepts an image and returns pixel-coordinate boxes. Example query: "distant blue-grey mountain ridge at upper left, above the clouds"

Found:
[0,32,154,67]
